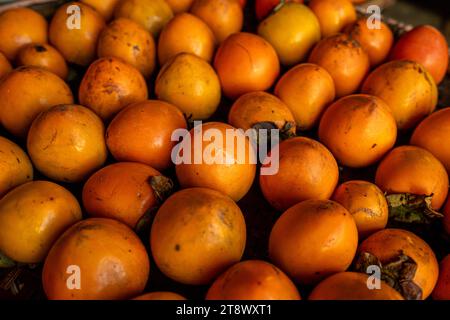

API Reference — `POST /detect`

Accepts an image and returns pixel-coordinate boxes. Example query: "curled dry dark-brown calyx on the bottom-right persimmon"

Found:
[354,252,423,300]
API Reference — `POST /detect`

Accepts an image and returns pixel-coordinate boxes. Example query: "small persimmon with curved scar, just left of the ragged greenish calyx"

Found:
[332,181,389,239]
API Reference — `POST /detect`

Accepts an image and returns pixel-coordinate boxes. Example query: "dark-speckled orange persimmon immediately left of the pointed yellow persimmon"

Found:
[78,57,148,121]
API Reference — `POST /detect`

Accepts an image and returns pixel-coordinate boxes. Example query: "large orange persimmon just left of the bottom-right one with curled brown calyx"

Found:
[269,200,358,285]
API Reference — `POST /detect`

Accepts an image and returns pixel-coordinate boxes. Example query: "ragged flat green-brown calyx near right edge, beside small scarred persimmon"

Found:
[386,193,444,224]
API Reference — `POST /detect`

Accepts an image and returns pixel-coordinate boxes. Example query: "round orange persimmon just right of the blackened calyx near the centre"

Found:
[319,95,397,168]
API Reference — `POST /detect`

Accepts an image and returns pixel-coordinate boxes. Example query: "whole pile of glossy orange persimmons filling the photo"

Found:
[0,0,450,300]
